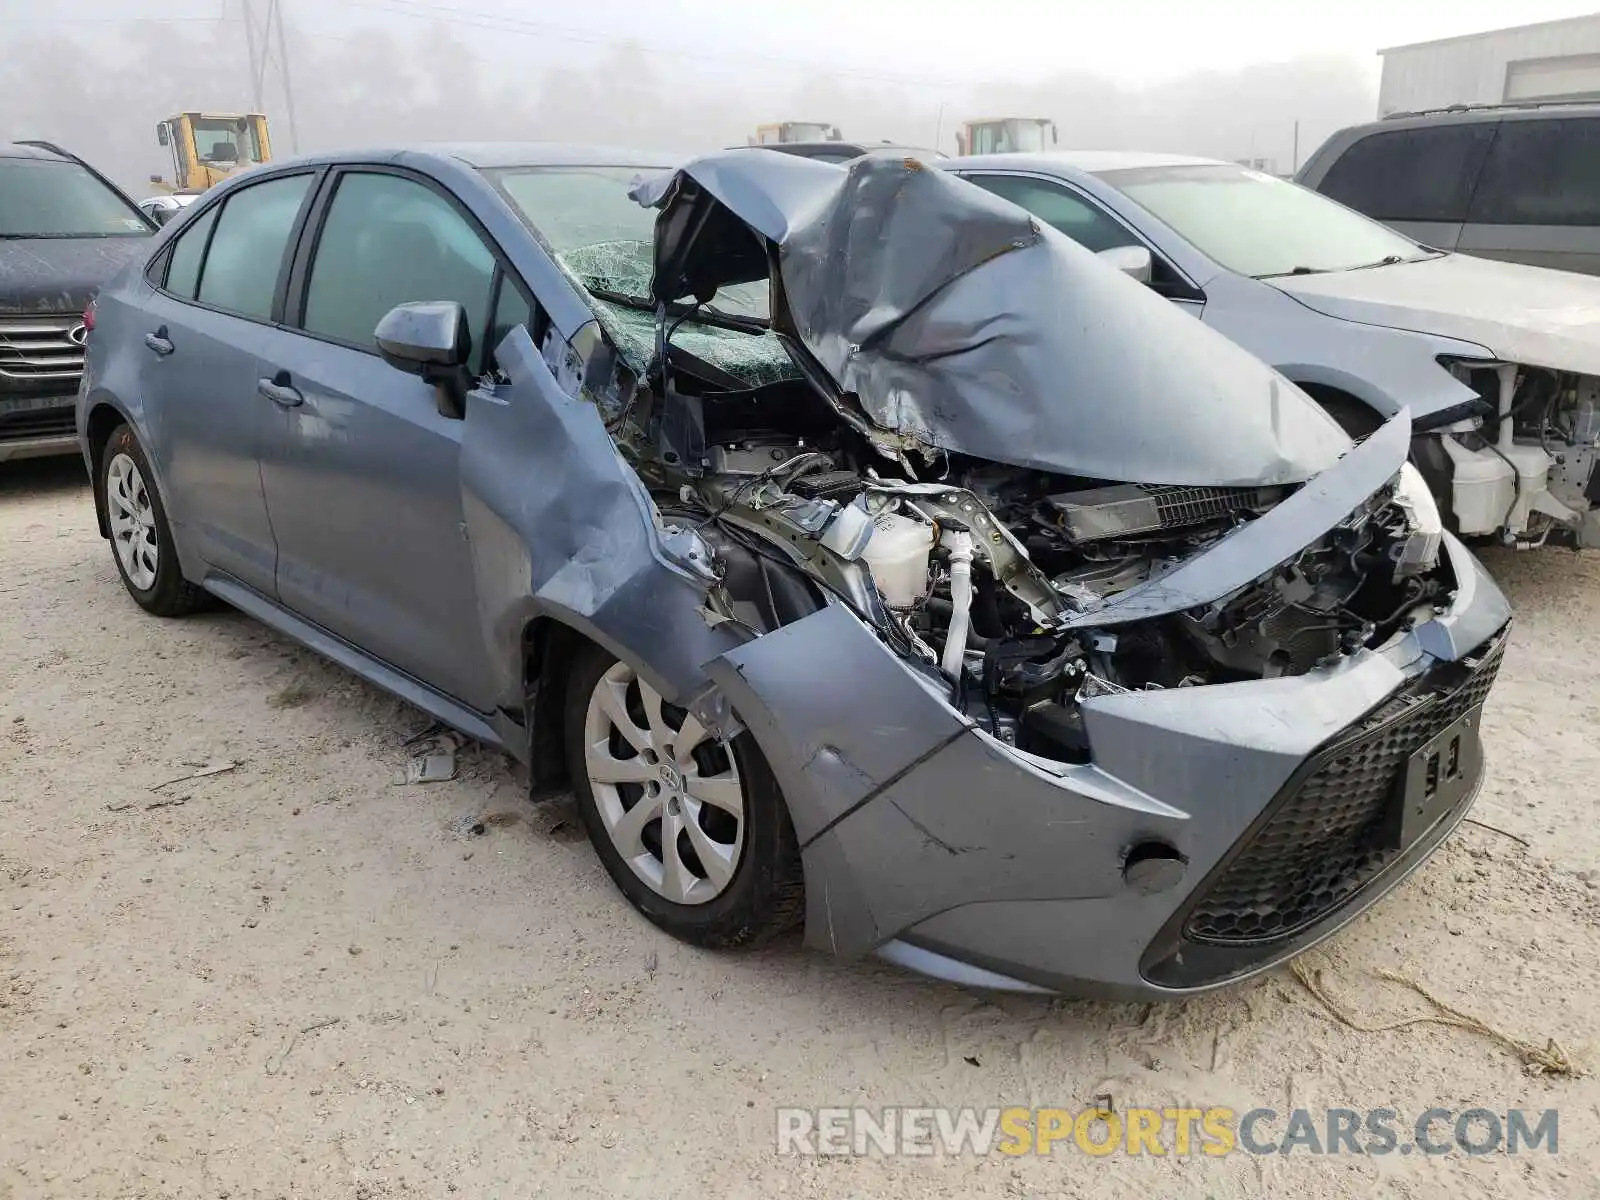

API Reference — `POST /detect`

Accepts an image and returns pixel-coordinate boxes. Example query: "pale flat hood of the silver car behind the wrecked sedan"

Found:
[1267,254,1600,374]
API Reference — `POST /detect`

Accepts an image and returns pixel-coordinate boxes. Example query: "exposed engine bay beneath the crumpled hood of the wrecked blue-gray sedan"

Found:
[610,354,1454,762]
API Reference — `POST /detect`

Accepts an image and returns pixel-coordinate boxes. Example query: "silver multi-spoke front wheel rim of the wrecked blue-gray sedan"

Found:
[584,662,746,904]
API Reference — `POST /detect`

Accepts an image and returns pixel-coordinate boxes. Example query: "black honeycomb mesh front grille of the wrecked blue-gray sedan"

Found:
[1184,634,1506,946]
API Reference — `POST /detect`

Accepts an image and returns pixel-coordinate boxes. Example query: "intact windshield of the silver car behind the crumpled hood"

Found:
[1099,163,1435,278]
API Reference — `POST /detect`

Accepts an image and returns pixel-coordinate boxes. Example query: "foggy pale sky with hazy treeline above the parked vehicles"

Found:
[0,0,1594,195]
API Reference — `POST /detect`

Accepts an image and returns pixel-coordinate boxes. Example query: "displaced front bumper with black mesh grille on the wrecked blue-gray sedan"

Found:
[709,538,1509,998]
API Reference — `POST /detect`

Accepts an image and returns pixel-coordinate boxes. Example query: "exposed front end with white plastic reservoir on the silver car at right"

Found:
[1413,362,1600,549]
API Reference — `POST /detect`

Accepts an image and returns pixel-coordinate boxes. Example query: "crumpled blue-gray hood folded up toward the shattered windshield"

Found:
[634,149,1349,486]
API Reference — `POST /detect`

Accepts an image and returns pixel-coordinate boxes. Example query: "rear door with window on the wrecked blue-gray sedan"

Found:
[138,171,317,595]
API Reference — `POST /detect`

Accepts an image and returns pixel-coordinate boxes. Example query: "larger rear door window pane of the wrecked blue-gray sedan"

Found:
[196,174,312,320]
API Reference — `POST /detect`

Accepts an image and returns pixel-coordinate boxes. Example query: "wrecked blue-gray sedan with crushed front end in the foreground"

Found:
[78,147,1509,997]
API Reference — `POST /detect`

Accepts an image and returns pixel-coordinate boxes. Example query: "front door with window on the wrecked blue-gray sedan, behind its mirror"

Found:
[252,166,512,712]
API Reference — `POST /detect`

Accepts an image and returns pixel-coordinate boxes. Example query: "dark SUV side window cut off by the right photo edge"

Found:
[1469,117,1600,226]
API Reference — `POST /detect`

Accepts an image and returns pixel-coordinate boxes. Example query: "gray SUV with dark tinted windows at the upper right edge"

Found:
[1296,102,1600,275]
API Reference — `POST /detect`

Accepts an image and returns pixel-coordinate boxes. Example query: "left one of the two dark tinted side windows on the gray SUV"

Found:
[1317,122,1494,222]
